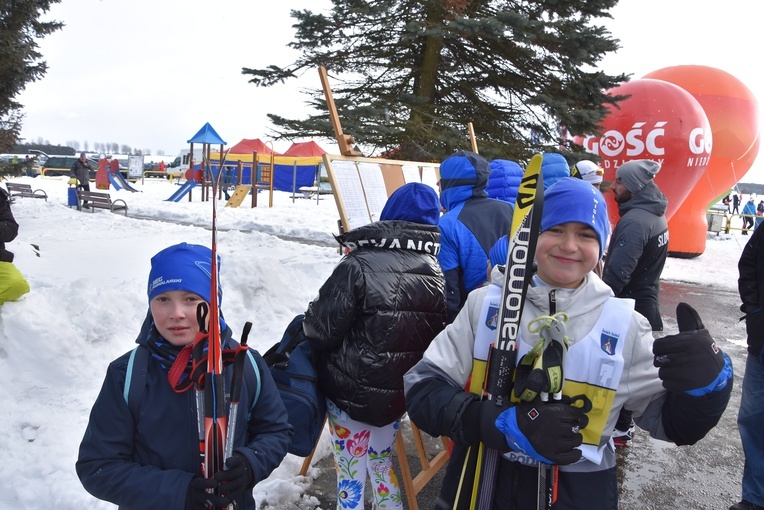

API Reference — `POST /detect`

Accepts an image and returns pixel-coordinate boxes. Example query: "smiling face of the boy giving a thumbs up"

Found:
[536,221,600,289]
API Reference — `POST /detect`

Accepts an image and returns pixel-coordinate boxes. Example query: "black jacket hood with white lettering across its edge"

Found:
[335,220,440,255]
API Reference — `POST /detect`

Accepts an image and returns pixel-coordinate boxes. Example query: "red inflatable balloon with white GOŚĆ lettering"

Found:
[575,79,711,229]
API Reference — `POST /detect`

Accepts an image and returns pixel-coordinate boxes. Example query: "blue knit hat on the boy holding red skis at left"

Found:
[148,243,223,305]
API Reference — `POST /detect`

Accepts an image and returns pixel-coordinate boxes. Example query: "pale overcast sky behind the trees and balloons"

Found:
[14,0,764,181]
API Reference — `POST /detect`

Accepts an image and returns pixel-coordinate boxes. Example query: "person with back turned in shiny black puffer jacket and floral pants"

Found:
[303,183,446,509]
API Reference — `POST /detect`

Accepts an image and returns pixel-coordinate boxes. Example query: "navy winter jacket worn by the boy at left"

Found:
[76,315,292,510]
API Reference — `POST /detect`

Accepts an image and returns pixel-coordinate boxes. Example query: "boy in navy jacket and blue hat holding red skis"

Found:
[76,243,292,510]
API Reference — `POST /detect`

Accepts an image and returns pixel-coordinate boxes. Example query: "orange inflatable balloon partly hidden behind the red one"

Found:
[645,65,760,258]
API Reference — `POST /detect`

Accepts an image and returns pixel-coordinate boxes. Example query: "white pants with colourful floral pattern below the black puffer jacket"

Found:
[326,399,403,510]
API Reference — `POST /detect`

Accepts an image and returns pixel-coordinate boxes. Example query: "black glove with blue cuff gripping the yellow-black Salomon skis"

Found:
[496,398,588,466]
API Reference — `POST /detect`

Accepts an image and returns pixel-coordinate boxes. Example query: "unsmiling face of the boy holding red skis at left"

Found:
[150,290,204,347]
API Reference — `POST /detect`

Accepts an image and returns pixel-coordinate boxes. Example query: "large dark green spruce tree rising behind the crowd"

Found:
[242,0,628,161]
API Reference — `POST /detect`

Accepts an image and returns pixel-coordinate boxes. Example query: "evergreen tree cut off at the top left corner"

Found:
[0,0,63,152]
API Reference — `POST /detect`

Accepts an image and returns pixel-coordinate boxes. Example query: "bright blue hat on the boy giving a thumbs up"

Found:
[541,177,610,258]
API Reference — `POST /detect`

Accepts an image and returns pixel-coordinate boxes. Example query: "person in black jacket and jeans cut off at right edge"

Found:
[730,228,764,510]
